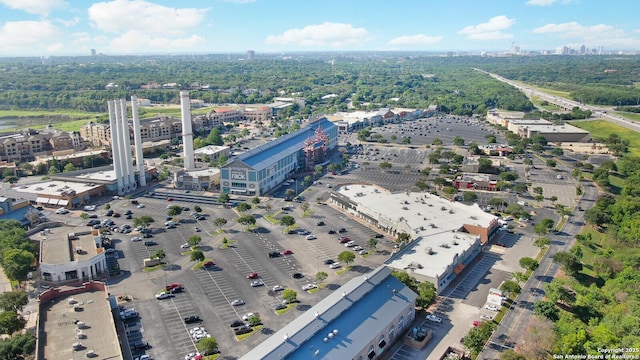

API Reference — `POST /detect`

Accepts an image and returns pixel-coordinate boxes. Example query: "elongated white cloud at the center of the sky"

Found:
[266,22,369,48]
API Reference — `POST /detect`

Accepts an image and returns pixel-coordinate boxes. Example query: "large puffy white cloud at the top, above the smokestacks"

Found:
[89,0,208,37]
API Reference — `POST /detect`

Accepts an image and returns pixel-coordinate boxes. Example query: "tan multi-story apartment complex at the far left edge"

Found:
[0,127,85,161]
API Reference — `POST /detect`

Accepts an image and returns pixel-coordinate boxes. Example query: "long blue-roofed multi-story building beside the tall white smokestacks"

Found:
[220,118,338,196]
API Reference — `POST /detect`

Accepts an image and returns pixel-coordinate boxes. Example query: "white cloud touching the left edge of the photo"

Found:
[0,20,61,54]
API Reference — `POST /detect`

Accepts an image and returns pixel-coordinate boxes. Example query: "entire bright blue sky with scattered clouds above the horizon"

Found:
[0,0,640,56]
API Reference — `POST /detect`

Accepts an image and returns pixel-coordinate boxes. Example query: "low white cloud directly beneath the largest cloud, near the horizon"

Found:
[108,30,205,54]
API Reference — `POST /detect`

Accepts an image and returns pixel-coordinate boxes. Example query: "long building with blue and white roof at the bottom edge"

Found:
[241,265,418,360]
